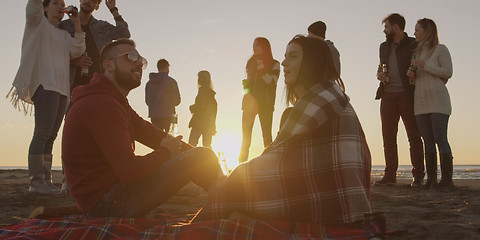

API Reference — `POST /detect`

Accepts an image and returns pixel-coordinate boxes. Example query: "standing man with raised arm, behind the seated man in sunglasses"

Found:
[58,0,130,94]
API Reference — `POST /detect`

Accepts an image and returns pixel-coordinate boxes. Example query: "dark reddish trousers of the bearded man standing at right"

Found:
[380,92,425,179]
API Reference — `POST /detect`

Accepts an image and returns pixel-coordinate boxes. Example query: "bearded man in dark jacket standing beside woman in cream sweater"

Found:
[375,13,425,187]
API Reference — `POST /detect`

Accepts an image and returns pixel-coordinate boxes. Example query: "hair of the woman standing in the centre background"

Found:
[246,37,274,76]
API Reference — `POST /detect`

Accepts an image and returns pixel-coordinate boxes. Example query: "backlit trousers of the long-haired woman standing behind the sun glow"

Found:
[239,111,273,162]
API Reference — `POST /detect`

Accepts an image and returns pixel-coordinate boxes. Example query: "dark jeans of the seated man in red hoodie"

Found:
[87,148,222,217]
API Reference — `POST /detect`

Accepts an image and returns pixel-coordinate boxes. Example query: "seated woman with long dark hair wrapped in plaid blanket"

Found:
[194,36,371,224]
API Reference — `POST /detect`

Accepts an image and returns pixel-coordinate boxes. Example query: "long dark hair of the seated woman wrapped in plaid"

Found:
[286,35,345,105]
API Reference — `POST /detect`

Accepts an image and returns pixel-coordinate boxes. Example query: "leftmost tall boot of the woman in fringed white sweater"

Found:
[28,154,58,194]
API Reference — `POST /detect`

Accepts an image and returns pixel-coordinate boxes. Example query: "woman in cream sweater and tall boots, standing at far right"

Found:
[407,18,453,187]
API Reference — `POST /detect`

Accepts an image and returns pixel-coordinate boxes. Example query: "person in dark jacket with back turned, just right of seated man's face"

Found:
[145,59,181,132]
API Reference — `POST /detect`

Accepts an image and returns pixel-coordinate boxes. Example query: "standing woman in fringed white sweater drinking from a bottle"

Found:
[7,0,85,194]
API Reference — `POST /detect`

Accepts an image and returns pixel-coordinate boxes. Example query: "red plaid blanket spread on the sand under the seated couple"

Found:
[0,216,379,240]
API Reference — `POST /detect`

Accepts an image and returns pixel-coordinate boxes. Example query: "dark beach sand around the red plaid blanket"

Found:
[0,170,480,239]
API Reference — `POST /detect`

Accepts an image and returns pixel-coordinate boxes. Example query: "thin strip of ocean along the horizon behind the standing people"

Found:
[0,165,480,179]
